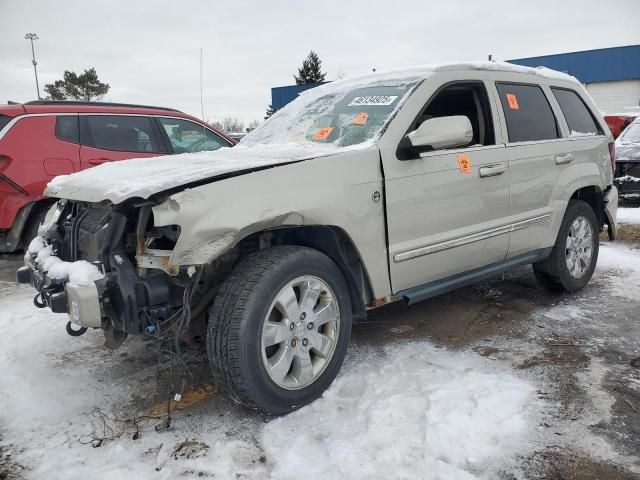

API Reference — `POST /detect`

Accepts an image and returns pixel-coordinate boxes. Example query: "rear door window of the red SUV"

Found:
[80,115,165,153]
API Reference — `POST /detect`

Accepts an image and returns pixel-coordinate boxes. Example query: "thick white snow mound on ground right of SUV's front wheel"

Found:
[262,342,538,479]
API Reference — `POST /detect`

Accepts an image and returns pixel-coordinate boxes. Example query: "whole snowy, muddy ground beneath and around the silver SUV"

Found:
[0,209,640,480]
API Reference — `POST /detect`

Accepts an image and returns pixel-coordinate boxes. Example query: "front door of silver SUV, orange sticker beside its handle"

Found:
[383,81,509,293]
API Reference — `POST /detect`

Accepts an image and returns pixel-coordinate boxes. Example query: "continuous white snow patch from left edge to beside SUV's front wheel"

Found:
[0,288,542,479]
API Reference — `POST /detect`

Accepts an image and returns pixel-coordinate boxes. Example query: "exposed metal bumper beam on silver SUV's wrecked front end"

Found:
[16,265,102,328]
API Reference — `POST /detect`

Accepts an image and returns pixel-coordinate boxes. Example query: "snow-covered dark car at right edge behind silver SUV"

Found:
[615,117,640,196]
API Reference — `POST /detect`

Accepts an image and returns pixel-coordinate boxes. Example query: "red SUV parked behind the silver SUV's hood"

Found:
[0,101,236,252]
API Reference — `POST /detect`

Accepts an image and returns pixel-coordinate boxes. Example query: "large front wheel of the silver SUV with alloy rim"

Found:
[207,246,352,415]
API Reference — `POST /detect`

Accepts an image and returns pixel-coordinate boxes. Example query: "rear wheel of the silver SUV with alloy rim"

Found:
[533,200,600,292]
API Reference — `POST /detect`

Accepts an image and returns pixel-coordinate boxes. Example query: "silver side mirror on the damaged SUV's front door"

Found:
[407,115,473,150]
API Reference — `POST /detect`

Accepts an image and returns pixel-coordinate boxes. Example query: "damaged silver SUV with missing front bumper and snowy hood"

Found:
[18,63,617,414]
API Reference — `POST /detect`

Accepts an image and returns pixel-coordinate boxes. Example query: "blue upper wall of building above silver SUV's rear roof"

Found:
[508,45,640,83]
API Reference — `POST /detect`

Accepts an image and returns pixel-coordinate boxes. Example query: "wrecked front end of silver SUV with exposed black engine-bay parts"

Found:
[18,201,233,348]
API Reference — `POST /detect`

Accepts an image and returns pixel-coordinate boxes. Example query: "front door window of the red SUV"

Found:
[158,117,229,153]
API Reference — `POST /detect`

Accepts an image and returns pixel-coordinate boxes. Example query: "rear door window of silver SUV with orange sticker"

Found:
[496,83,559,142]
